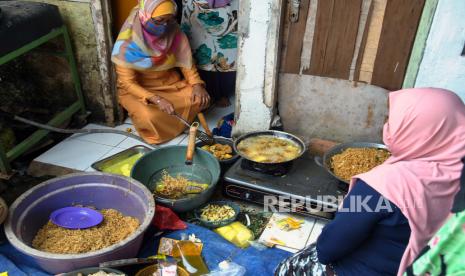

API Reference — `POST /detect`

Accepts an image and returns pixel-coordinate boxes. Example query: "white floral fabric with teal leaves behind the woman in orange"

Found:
[181,0,239,72]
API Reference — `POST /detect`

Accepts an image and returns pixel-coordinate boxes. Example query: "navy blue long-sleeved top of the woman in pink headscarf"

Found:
[317,180,411,276]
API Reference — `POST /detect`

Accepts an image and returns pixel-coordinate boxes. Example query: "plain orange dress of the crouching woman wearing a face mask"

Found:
[116,66,203,144]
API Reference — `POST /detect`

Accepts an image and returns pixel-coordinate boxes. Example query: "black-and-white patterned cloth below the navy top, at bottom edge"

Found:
[274,244,327,276]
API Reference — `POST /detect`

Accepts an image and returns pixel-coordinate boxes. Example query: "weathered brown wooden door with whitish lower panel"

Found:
[278,0,425,141]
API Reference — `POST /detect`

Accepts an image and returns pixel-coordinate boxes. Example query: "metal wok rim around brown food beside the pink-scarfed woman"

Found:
[315,142,388,184]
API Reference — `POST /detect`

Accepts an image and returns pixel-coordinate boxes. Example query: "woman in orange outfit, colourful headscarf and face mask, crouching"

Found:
[112,0,210,144]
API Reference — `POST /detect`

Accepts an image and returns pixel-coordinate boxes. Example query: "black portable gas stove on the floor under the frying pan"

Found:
[224,156,346,220]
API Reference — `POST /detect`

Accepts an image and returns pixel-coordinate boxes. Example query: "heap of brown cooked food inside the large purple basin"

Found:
[32,209,140,254]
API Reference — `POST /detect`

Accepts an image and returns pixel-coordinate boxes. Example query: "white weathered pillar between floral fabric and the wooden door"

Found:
[234,0,281,135]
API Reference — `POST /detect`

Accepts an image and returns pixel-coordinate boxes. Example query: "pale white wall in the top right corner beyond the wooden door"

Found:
[415,0,465,101]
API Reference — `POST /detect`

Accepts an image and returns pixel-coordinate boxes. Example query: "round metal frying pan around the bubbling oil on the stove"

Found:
[234,130,307,165]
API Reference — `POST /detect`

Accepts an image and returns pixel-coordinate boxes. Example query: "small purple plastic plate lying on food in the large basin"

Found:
[50,207,103,229]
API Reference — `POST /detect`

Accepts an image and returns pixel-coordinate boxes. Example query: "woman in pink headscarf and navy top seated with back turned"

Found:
[276,88,465,276]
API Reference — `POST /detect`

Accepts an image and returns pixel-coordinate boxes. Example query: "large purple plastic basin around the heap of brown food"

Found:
[5,172,155,274]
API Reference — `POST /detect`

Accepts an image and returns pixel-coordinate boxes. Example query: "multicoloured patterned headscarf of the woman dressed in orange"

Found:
[112,0,192,71]
